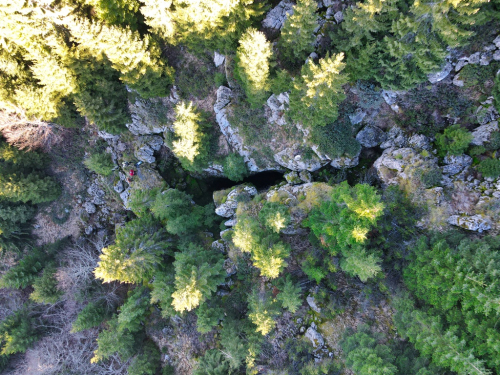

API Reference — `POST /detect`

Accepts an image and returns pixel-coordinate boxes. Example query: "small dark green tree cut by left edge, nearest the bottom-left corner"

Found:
[0,306,39,355]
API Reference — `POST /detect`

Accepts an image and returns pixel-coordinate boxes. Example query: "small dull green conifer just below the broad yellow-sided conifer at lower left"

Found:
[118,286,150,332]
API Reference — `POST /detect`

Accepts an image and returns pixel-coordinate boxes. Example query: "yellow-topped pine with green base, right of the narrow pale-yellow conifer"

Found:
[289,53,347,127]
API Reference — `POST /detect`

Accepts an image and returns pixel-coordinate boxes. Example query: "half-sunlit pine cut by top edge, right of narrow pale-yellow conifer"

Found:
[279,0,318,62]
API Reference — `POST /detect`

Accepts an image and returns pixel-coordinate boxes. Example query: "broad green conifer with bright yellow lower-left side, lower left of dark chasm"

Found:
[94,216,170,283]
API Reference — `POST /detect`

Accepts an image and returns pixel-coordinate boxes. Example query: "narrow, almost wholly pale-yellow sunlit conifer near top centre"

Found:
[236,28,272,108]
